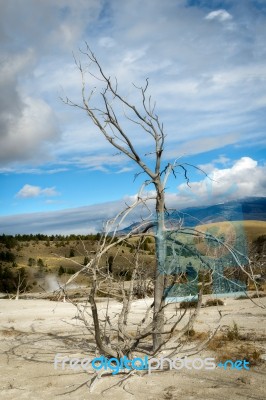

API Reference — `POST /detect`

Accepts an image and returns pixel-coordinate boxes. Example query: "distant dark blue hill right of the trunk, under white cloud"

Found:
[119,197,266,235]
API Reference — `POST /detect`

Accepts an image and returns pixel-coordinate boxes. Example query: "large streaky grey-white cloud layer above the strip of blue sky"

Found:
[0,0,266,169]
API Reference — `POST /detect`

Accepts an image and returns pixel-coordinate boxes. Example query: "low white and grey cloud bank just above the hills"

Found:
[0,157,266,234]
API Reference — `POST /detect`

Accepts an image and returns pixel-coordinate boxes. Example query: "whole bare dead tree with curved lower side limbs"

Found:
[62,44,262,357]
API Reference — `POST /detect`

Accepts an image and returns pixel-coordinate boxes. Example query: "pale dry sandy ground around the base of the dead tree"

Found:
[0,298,266,400]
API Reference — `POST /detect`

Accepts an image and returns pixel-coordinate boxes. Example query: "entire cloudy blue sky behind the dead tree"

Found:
[0,0,266,234]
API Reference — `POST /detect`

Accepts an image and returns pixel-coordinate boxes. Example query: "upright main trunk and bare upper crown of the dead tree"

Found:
[63,44,208,350]
